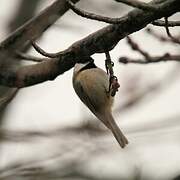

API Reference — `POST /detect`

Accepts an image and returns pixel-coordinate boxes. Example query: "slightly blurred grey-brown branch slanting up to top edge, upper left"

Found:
[0,0,79,53]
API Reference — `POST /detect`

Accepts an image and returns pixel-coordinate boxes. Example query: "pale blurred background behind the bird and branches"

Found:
[0,0,180,180]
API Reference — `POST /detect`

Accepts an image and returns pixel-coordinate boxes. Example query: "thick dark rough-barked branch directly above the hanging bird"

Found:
[0,0,180,87]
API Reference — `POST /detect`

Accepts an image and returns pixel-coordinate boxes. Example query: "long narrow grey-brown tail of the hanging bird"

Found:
[100,112,128,148]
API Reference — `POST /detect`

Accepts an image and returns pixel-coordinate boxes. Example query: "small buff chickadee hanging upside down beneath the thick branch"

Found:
[73,60,128,148]
